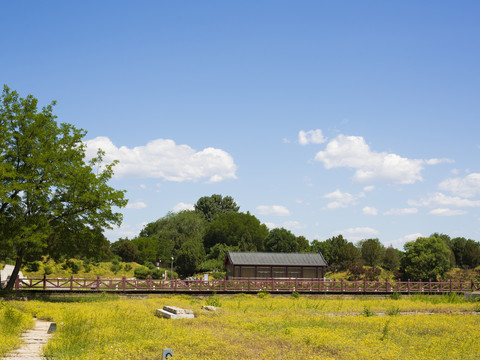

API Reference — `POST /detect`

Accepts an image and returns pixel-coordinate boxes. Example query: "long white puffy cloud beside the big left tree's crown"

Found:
[85,136,237,182]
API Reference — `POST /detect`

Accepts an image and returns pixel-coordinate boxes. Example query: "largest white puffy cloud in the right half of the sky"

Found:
[315,135,450,184]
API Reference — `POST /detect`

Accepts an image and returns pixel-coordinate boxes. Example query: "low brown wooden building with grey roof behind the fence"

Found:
[225,252,327,280]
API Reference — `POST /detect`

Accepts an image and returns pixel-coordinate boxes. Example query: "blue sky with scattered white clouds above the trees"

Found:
[0,1,480,248]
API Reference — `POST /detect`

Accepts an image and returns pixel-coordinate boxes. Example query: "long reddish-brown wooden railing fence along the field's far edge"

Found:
[3,276,480,294]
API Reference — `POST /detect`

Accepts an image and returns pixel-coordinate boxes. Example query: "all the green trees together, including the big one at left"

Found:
[0,86,480,289]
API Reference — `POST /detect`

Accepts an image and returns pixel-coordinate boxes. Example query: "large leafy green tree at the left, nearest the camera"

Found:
[0,86,127,290]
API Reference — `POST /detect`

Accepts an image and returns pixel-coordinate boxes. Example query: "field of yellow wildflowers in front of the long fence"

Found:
[2,294,480,360]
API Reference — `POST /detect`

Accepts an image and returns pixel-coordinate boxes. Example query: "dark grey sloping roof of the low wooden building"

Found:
[227,252,327,266]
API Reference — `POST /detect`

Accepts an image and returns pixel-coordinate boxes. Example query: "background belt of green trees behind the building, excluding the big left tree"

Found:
[111,195,480,280]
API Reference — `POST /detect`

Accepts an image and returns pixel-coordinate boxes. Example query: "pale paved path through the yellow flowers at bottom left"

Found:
[4,319,51,360]
